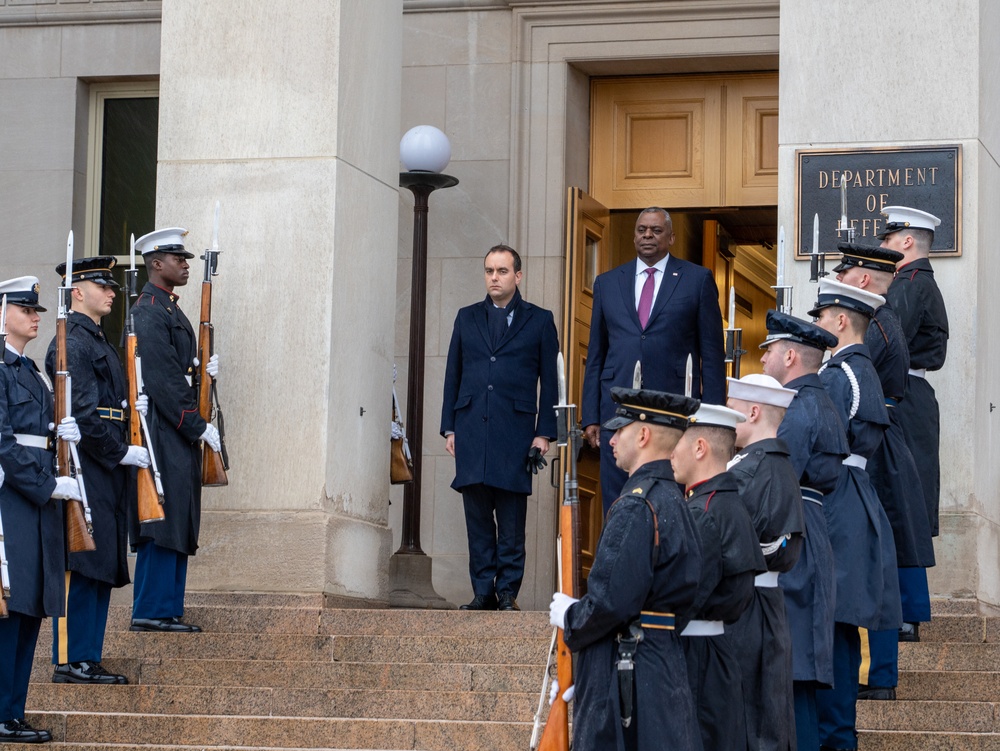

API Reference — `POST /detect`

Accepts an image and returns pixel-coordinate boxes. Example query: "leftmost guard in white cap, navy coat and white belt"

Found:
[0,276,80,743]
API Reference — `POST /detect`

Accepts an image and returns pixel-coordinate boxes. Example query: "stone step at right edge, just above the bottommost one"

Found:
[858,700,1000,733]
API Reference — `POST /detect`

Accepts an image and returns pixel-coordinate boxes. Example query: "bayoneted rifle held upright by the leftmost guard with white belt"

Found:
[54,230,97,553]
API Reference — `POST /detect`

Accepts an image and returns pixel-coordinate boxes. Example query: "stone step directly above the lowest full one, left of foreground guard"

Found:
[28,683,538,722]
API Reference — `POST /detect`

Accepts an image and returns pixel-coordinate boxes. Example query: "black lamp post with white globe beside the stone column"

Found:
[389,125,458,609]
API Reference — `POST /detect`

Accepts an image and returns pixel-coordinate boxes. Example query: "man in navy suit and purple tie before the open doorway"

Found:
[581,208,726,514]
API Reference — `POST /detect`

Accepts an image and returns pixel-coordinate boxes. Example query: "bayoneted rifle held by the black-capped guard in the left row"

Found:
[125,235,166,524]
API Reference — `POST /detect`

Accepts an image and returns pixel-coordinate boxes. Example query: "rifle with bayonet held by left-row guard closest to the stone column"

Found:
[198,201,229,487]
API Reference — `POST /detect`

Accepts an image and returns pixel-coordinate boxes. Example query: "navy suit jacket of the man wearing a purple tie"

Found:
[581,256,726,426]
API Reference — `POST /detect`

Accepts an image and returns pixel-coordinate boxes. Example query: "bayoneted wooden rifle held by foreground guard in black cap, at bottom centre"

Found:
[530,352,583,751]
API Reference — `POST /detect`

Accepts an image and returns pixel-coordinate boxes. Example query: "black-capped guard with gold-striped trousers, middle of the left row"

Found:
[45,256,149,683]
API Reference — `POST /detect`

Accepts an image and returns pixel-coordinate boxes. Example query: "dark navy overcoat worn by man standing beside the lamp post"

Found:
[441,297,559,494]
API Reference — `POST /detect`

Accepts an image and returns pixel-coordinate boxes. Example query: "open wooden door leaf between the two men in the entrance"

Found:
[559,188,612,579]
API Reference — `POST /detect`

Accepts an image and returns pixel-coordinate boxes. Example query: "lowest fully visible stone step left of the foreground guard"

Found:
[27,711,531,751]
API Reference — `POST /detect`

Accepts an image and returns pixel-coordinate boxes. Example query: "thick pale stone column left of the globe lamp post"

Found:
[156,0,402,602]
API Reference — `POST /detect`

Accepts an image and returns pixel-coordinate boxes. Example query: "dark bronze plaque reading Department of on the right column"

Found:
[792,145,962,257]
